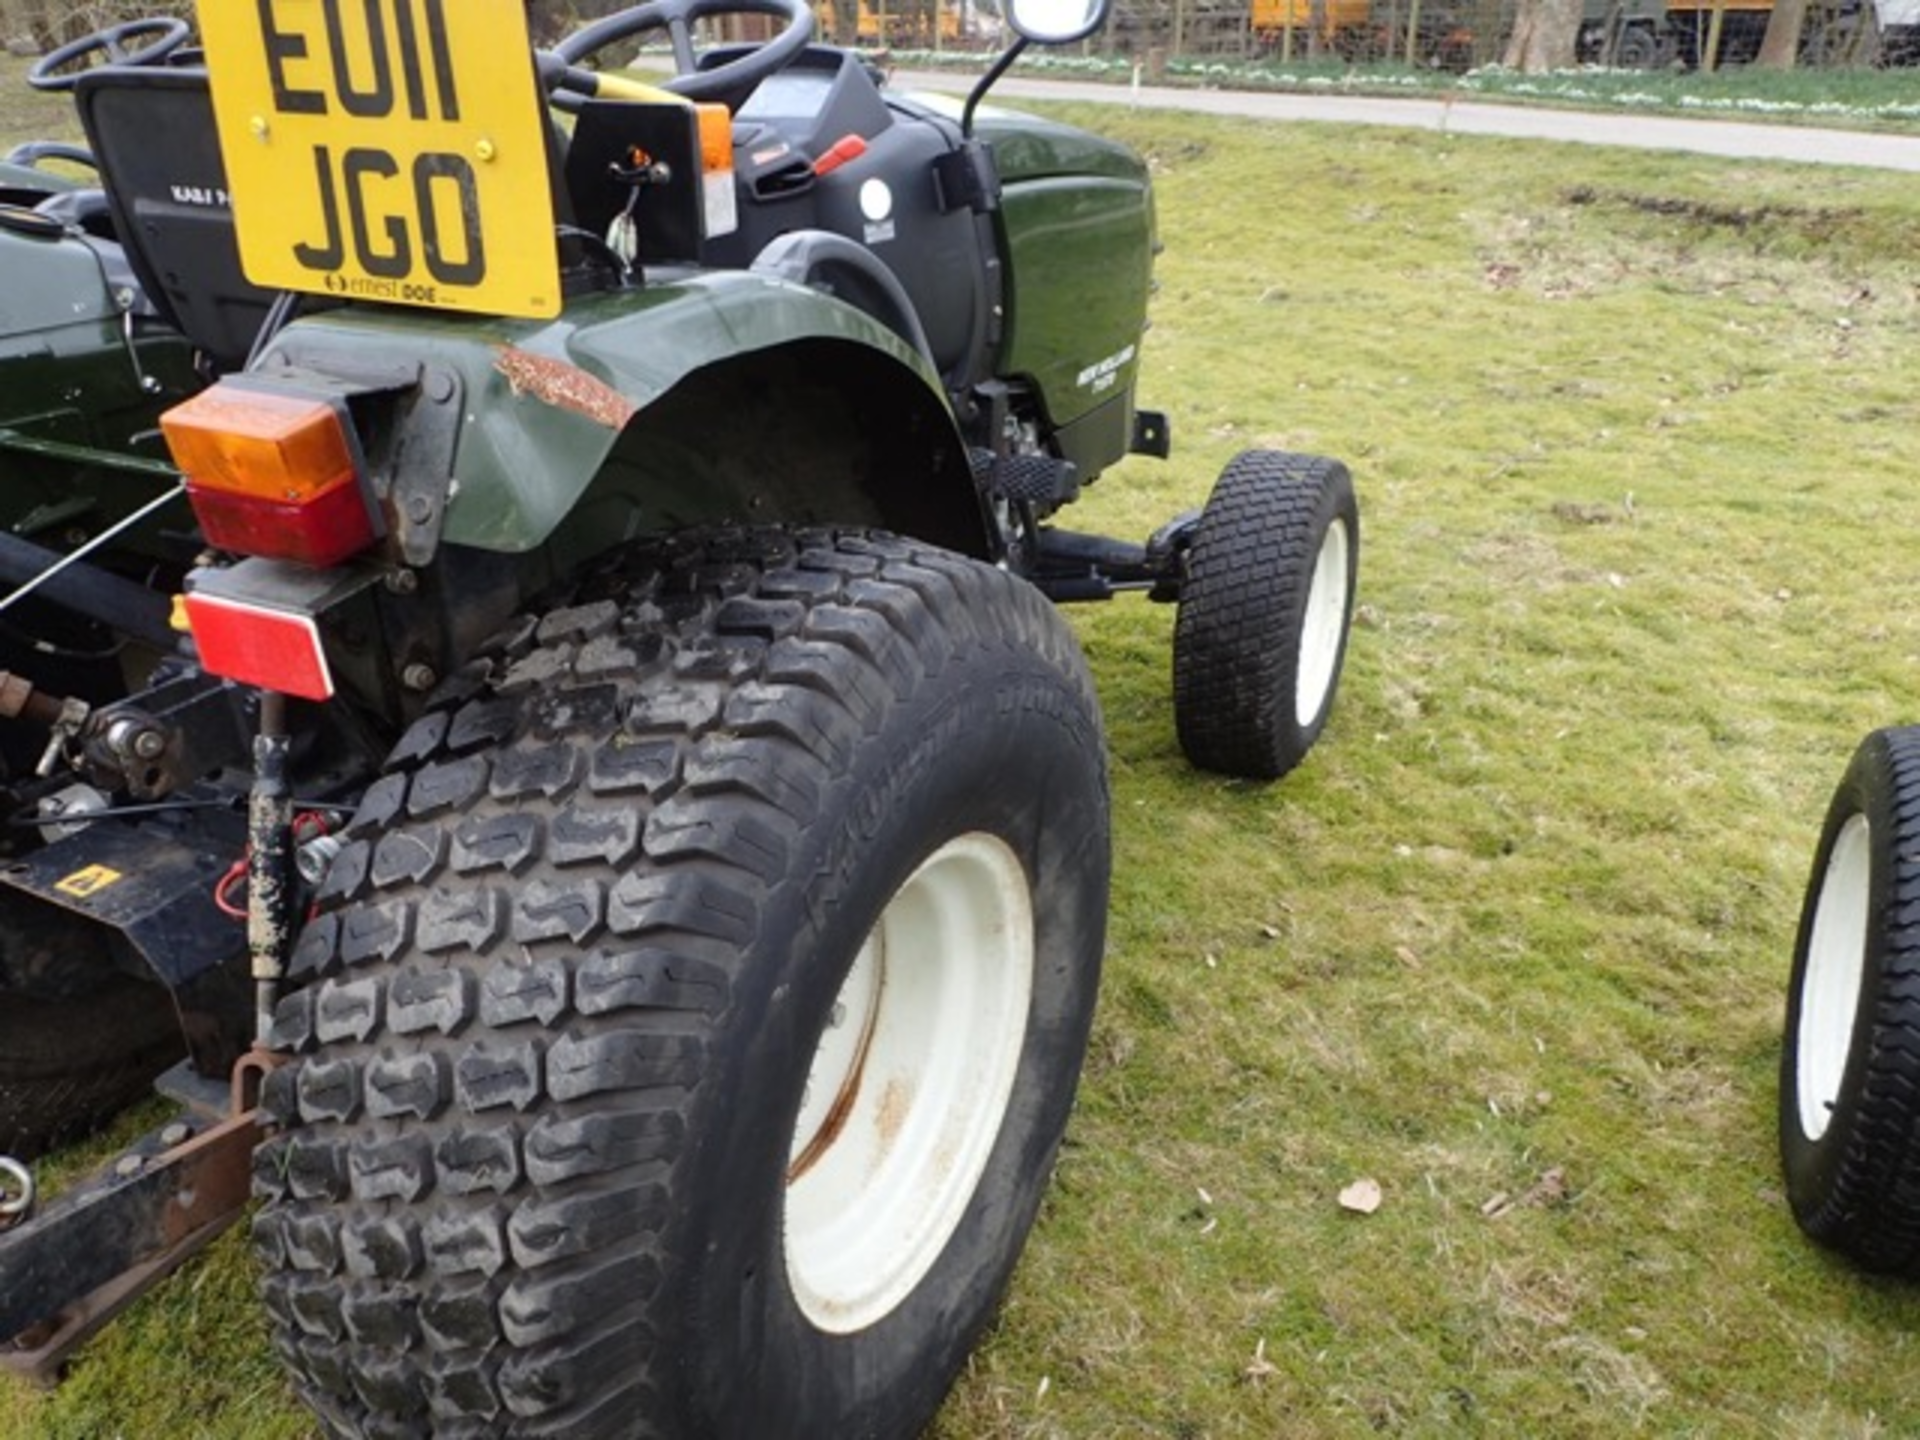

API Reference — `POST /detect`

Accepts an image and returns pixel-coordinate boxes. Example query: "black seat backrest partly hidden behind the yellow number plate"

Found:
[77,65,273,371]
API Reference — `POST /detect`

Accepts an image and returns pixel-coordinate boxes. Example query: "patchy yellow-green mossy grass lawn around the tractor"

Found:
[0,45,1920,1440]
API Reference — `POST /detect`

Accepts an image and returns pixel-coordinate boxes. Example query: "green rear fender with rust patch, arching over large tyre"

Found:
[263,269,983,553]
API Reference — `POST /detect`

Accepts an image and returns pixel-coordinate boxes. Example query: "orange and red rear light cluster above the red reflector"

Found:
[159,380,380,568]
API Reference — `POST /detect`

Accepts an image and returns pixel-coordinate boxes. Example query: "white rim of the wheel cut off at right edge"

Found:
[1793,814,1874,1140]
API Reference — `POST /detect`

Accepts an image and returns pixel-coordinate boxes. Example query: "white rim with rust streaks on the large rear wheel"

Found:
[785,833,1033,1334]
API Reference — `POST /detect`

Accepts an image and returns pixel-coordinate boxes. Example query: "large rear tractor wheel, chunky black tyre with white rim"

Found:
[255,532,1108,1440]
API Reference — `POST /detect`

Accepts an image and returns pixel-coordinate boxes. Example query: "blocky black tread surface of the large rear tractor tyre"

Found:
[253,530,1091,1440]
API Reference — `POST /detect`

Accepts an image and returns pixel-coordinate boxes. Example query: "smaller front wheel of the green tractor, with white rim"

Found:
[1173,449,1359,780]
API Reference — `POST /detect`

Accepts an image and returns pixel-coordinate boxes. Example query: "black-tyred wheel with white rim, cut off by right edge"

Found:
[1780,728,1920,1273]
